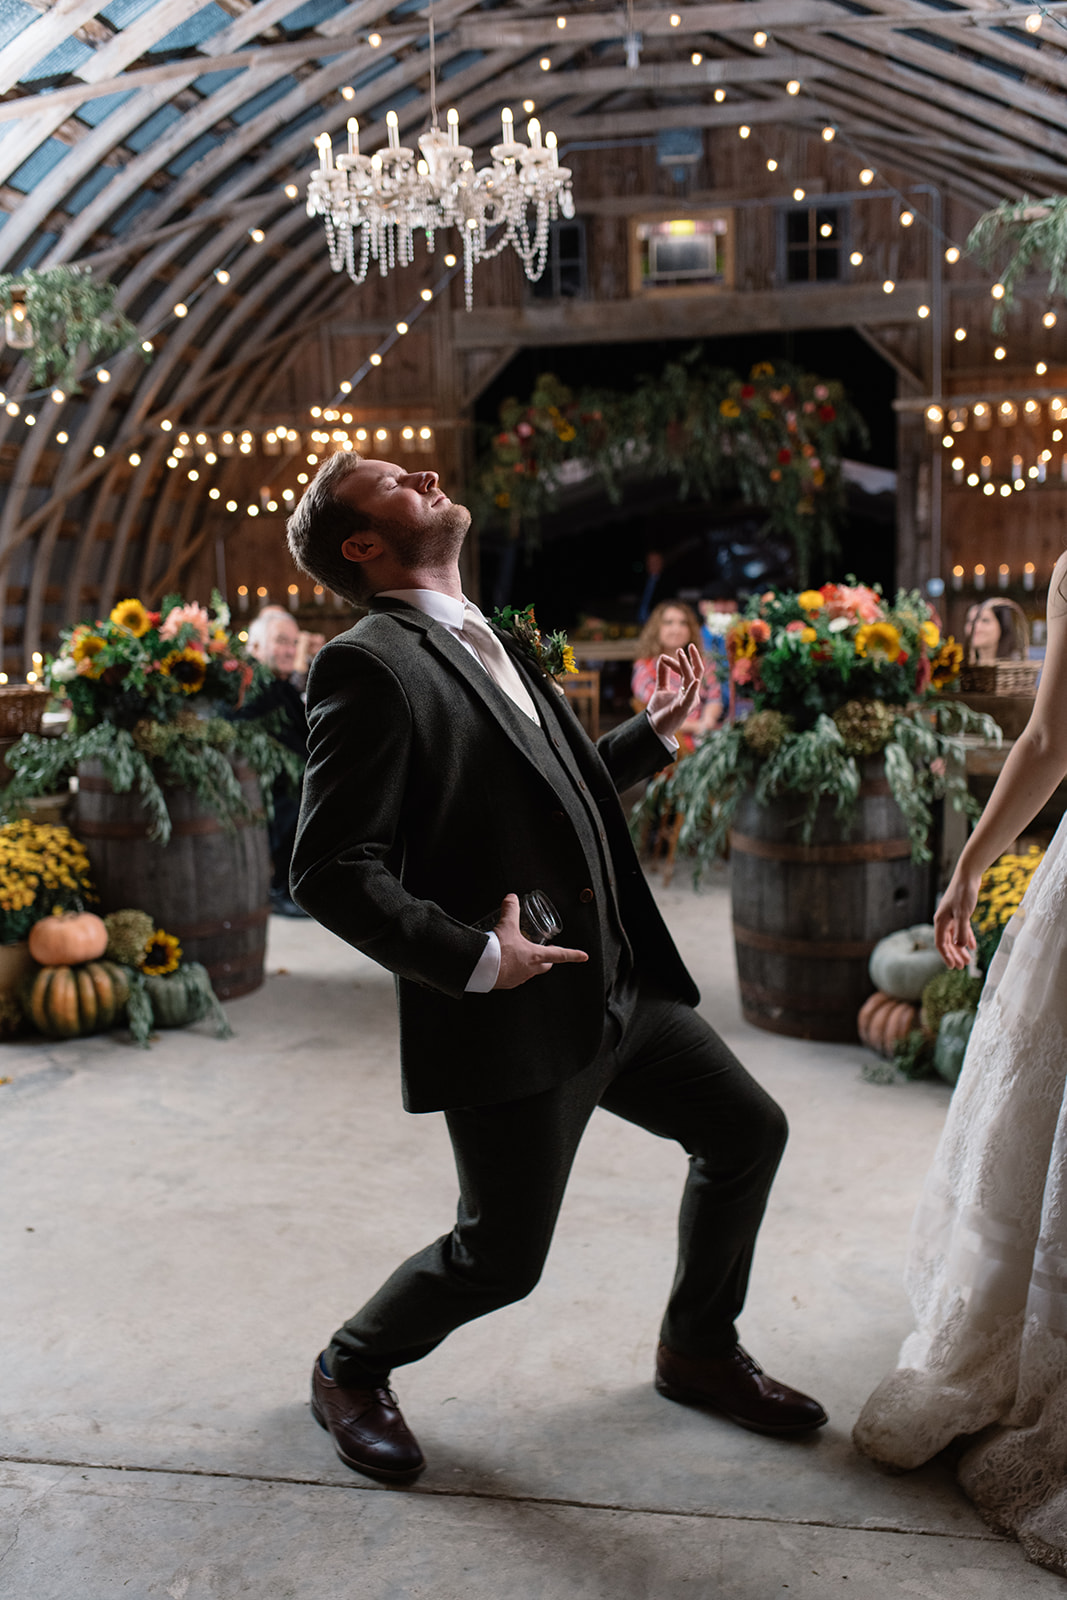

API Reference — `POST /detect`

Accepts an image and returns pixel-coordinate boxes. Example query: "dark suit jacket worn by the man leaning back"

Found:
[291,600,697,1112]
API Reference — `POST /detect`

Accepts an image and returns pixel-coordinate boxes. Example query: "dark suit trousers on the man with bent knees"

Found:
[326,978,787,1387]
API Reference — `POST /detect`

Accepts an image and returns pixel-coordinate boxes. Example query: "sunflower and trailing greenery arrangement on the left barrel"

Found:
[0,594,299,843]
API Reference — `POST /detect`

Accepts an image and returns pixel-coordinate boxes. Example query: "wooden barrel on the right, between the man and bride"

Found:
[729,762,933,1043]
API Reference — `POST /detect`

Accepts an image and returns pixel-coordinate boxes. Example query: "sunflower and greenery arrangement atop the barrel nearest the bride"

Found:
[637,581,1000,874]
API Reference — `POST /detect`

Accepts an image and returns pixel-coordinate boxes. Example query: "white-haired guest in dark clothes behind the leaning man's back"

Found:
[234,605,307,917]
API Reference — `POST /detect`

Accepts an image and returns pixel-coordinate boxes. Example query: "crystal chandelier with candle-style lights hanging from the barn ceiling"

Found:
[307,16,574,310]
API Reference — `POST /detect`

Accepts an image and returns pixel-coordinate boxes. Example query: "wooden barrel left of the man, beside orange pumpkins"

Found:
[74,762,270,1000]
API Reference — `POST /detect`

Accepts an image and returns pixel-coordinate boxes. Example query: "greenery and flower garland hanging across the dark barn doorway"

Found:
[475,347,865,584]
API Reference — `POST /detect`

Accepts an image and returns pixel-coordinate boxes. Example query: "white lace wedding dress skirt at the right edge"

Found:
[853,818,1067,1576]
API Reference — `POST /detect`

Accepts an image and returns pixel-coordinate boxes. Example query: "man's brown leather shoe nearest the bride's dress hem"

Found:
[656,1344,827,1435]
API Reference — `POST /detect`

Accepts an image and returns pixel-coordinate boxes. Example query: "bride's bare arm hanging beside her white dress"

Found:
[934,554,1067,966]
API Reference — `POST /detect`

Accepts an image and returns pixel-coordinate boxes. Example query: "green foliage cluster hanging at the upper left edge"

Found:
[0,266,150,394]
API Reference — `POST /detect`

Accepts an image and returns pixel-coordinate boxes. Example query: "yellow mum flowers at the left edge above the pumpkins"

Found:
[0,821,98,944]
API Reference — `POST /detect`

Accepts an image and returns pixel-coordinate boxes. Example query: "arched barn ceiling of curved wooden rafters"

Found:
[0,0,1067,653]
